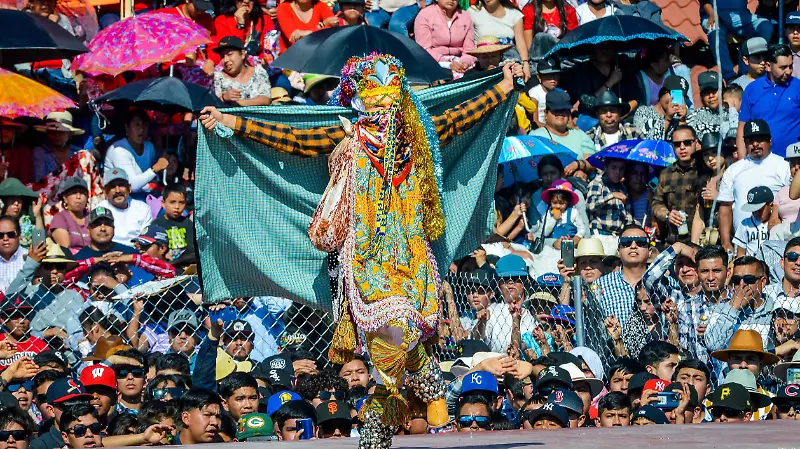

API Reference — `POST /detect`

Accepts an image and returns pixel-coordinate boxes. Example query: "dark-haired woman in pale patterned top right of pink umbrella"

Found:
[214,36,272,106]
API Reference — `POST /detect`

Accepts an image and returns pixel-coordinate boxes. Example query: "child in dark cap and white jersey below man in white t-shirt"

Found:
[733,186,775,257]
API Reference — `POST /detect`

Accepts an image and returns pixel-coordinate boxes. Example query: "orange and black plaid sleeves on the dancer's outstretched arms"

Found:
[234,86,506,157]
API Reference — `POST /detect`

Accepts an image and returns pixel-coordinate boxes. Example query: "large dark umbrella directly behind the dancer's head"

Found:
[272,25,451,84]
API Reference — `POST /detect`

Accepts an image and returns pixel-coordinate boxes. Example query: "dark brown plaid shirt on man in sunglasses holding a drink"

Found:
[653,159,700,243]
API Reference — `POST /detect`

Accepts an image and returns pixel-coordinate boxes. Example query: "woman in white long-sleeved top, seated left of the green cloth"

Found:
[105,109,169,200]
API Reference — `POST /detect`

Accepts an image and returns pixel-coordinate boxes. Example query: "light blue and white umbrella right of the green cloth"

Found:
[498,136,578,187]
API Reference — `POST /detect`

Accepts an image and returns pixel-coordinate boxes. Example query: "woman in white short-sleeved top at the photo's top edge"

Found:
[469,0,531,81]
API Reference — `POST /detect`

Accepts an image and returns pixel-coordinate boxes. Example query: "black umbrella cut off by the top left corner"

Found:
[0,9,89,67]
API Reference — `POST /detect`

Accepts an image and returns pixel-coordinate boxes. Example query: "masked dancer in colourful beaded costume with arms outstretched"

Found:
[200,54,523,449]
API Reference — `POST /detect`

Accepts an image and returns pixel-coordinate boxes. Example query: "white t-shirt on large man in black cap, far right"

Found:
[717,153,792,228]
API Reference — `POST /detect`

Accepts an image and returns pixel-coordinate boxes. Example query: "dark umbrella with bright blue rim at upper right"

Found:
[545,16,688,58]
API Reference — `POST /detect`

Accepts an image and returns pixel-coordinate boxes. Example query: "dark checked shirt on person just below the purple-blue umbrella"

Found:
[586,175,633,235]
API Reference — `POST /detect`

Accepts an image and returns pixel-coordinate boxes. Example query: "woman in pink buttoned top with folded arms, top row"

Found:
[414,0,476,74]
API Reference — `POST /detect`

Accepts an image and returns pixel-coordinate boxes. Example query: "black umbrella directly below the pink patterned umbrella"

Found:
[93,77,225,112]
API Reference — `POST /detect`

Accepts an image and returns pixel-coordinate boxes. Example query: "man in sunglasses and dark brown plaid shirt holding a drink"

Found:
[653,125,700,243]
